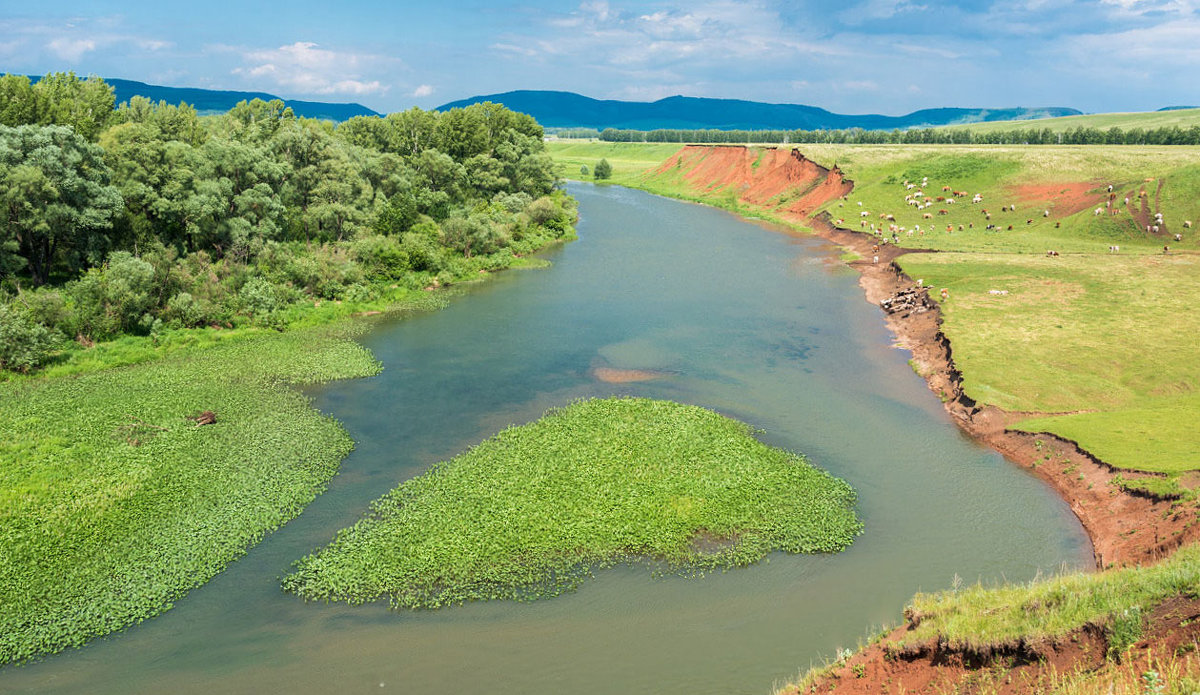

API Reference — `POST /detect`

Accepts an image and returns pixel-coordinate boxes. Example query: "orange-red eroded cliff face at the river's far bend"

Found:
[654,145,853,217]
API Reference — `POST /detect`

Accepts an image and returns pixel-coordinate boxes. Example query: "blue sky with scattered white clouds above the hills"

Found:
[0,0,1200,114]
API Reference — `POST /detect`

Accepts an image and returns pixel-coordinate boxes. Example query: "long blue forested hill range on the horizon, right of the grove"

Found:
[438,90,1081,131]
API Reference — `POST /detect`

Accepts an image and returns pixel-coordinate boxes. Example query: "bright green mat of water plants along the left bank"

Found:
[0,324,379,664]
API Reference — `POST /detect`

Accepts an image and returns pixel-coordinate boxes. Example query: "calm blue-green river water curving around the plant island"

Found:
[0,184,1091,695]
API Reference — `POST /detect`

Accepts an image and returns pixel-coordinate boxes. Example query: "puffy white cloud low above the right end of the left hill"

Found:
[233,41,395,96]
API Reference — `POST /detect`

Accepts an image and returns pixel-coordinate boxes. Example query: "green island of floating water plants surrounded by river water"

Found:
[283,399,862,609]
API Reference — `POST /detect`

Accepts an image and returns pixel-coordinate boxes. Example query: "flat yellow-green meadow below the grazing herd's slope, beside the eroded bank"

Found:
[899,253,1200,473]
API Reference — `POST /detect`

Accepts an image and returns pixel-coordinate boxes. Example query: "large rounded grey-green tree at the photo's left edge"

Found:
[0,126,122,284]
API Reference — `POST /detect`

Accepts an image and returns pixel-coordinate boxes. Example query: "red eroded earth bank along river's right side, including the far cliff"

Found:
[552,145,1200,568]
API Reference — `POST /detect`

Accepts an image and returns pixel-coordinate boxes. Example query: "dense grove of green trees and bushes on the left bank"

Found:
[0,74,575,370]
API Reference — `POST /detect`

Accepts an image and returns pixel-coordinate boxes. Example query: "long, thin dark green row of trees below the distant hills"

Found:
[590,126,1200,145]
